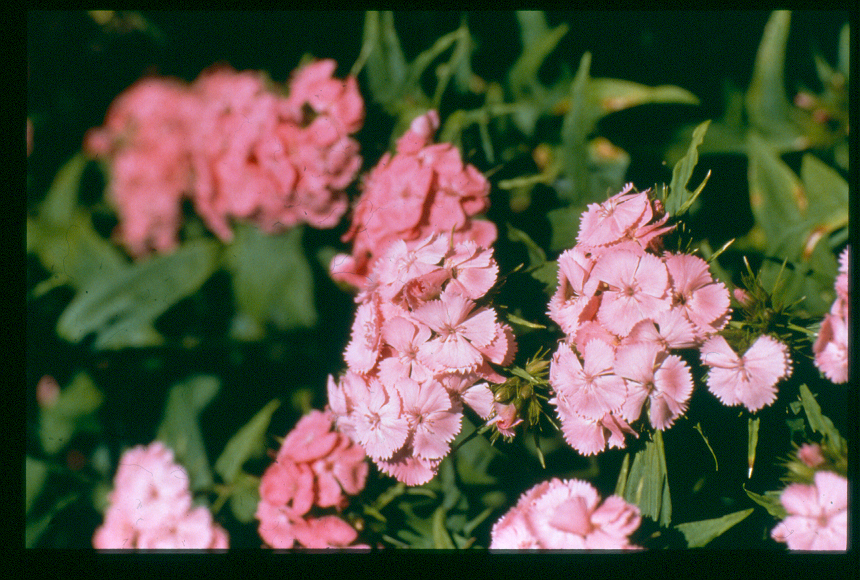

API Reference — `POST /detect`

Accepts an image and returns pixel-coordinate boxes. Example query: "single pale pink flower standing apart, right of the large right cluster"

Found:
[700,334,792,411]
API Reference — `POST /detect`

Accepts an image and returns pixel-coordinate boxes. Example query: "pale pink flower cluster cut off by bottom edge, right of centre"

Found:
[490,478,642,550]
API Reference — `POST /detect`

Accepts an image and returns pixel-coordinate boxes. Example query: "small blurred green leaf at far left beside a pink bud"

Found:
[39,372,104,455]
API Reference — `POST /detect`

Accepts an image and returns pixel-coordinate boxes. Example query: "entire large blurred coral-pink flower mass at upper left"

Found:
[84,60,364,256]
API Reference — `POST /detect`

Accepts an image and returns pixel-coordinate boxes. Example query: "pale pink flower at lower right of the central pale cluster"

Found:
[402,380,463,459]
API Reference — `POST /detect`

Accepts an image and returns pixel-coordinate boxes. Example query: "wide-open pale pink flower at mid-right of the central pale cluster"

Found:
[412,290,496,372]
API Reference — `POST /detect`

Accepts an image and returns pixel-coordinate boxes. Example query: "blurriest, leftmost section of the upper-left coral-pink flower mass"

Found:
[84,78,199,257]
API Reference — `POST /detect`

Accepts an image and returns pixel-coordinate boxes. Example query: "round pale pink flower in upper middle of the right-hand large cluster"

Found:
[591,250,671,336]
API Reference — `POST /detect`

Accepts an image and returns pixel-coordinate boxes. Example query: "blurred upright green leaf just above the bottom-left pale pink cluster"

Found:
[155,375,221,491]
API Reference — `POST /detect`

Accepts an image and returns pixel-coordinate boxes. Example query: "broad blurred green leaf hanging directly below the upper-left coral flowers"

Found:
[225,225,317,340]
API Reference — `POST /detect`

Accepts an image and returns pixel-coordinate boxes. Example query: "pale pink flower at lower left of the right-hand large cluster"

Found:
[550,340,627,420]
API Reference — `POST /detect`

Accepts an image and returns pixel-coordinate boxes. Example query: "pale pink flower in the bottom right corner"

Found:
[771,471,848,550]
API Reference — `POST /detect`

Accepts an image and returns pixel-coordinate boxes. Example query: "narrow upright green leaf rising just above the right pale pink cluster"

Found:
[558,52,593,203]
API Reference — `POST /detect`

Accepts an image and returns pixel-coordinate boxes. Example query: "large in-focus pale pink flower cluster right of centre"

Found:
[549,184,729,455]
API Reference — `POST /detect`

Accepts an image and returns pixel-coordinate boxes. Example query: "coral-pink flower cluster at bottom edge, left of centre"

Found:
[256,411,368,549]
